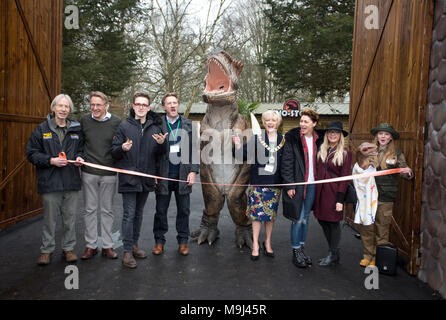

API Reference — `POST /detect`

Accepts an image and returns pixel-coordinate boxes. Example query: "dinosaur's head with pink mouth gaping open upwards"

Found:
[203,49,243,104]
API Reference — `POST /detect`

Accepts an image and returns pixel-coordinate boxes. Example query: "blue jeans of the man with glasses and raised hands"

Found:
[122,192,149,252]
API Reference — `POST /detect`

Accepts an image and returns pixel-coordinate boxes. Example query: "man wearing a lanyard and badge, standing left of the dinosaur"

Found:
[152,93,199,256]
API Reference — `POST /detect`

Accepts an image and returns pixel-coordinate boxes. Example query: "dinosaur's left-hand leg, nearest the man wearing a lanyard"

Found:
[190,180,225,245]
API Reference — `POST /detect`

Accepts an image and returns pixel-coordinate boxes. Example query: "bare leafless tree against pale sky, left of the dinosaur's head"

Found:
[125,0,230,116]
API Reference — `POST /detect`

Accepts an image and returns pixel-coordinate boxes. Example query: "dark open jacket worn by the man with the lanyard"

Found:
[155,114,200,195]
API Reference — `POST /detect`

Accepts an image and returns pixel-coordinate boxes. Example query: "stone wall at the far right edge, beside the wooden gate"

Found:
[418,0,446,298]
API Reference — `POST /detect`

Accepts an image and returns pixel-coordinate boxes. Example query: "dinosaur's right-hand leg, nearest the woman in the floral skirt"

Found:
[227,187,252,249]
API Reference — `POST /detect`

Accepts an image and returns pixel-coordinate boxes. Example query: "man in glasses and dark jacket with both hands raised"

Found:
[112,93,167,268]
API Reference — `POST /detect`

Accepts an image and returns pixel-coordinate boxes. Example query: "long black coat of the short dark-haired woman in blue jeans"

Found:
[280,128,324,221]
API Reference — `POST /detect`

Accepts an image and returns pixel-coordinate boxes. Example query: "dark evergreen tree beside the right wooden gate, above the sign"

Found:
[265,0,354,100]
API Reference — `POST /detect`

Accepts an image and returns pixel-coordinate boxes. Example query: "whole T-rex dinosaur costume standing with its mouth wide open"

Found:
[191,49,252,247]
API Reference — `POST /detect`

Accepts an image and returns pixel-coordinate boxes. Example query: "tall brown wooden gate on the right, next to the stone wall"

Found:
[346,0,434,274]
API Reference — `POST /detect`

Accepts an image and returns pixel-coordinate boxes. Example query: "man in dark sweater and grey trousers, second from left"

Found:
[81,91,121,260]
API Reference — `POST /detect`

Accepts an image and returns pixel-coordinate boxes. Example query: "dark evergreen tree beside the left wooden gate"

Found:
[62,0,139,112]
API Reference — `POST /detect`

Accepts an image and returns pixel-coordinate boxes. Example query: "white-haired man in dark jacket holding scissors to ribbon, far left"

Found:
[26,94,84,265]
